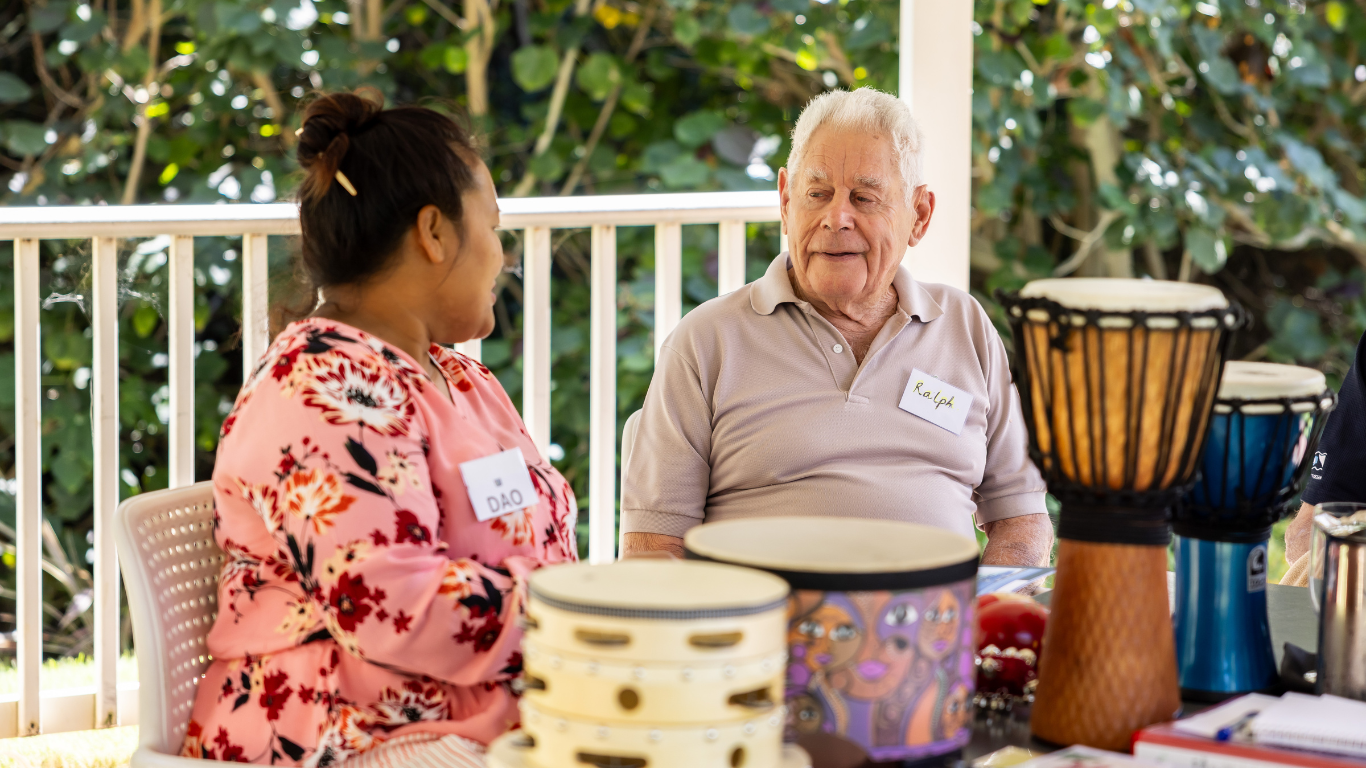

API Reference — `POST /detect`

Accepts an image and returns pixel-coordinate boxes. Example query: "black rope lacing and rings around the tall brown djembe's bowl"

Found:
[996,290,1247,545]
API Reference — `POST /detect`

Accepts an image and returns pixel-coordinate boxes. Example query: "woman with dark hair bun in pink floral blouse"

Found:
[183,93,578,768]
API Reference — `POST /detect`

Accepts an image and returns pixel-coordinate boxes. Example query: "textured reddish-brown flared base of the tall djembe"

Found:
[1030,538,1182,752]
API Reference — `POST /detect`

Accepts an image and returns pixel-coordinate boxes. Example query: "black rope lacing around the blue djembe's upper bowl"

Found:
[1172,389,1337,544]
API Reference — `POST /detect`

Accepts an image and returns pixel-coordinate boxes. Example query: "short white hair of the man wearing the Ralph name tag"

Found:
[787,87,925,195]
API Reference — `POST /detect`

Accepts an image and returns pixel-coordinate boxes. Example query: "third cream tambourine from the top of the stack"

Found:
[522,700,783,768]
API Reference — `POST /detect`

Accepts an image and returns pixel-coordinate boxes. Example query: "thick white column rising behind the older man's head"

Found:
[900,0,973,290]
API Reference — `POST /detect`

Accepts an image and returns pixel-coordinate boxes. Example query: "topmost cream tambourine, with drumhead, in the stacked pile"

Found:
[526,560,788,668]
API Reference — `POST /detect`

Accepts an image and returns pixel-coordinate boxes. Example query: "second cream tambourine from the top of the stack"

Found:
[523,641,787,726]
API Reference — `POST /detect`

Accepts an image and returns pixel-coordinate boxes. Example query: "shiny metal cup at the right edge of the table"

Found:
[1309,502,1366,701]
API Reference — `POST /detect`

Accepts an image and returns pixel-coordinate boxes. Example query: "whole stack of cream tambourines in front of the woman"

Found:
[489,560,809,768]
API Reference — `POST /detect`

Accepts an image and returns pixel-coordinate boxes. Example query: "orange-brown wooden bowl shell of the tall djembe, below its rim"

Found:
[1020,317,1224,492]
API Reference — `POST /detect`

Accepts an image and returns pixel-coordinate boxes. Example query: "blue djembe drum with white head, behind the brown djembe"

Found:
[1172,362,1337,701]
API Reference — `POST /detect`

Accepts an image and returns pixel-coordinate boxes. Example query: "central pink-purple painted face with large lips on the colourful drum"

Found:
[832,592,919,700]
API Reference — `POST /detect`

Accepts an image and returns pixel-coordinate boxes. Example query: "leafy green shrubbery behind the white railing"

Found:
[0,0,1366,655]
